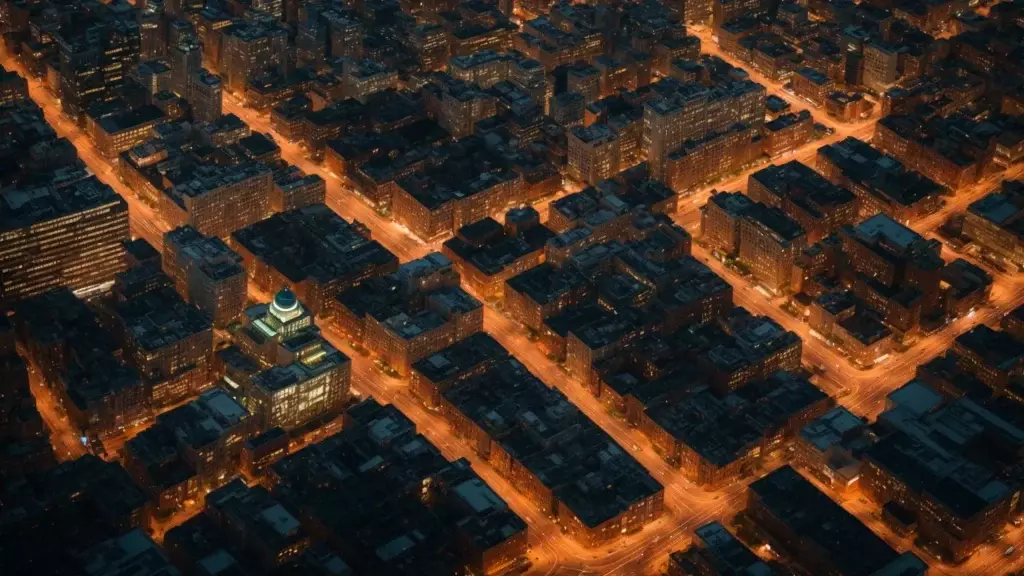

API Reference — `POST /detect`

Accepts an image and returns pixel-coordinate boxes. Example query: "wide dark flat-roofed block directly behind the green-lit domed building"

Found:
[229,204,398,315]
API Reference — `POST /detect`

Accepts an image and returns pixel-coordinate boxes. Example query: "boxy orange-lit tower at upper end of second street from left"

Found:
[221,23,288,94]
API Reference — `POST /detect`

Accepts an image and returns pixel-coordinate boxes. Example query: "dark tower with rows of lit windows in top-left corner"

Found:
[57,7,140,122]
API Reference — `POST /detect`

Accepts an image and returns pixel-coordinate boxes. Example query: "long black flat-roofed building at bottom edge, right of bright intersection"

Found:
[746,465,928,576]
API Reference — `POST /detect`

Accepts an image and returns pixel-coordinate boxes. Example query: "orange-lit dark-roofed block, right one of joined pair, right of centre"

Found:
[738,203,807,293]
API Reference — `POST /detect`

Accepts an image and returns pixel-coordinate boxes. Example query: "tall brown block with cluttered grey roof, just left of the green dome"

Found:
[163,225,248,327]
